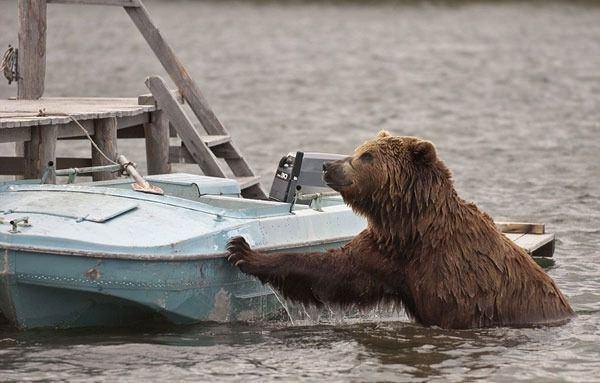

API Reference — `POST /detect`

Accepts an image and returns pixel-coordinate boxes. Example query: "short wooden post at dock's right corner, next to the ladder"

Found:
[144,110,171,175]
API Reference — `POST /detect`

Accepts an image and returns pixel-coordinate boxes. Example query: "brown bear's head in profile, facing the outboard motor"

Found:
[323,131,454,224]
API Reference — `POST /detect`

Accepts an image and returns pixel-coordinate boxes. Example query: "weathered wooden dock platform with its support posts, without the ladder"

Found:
[0,97,159,184]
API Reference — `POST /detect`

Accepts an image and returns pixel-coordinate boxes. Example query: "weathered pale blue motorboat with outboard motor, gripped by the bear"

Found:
[0,153,554,329]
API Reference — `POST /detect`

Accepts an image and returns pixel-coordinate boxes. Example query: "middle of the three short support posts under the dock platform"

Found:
[92,117,117,181]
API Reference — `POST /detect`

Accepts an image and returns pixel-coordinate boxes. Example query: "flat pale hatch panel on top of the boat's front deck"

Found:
[0,192,138,223]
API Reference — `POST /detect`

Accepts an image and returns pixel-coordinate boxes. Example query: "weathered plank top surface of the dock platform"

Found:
[0,97,156,131]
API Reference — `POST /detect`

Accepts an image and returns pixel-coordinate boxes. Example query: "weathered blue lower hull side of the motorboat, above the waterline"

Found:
[0,243,342,329]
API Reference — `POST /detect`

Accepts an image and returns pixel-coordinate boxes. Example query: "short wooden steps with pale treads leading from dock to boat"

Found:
[146,76,266,199]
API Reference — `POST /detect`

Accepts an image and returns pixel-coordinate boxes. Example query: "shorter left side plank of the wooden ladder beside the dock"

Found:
[146,76,225,178]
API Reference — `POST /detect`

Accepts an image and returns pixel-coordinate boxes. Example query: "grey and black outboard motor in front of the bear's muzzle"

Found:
[269,152,347,203]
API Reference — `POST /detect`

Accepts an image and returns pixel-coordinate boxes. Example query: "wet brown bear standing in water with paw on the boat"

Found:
[228,132,573,329]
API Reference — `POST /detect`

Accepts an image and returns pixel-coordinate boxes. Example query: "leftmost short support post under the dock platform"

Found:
[25,125,58,183]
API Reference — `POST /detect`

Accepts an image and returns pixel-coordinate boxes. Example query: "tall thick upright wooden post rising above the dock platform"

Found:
[17,0,46,100]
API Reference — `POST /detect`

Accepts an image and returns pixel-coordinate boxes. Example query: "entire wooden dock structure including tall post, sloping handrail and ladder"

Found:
[0,0,266,198]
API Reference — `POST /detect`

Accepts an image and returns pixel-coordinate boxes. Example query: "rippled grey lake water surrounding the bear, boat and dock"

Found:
[0,1,600,382]
